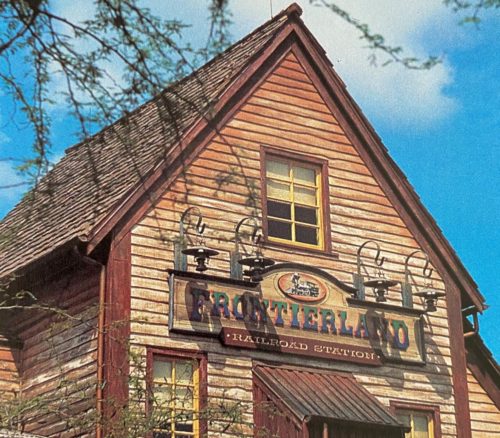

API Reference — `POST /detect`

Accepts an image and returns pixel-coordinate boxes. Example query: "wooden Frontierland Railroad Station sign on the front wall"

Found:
[169,264,424,365]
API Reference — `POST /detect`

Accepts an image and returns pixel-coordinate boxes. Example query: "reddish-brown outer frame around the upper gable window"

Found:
[260,145,331,253]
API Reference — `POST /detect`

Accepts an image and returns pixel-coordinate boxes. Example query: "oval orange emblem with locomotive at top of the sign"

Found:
[278,272,327,303]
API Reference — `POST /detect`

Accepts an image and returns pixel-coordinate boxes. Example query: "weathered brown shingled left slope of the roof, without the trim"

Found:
[0,4,296,277]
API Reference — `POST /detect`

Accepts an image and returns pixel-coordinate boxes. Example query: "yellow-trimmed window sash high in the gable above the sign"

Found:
[265,156,324,249]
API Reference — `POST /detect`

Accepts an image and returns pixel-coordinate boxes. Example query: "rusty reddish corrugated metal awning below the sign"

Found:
[254,365,404,429]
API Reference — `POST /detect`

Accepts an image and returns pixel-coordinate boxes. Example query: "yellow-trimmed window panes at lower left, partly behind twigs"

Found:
[152,356,200,438]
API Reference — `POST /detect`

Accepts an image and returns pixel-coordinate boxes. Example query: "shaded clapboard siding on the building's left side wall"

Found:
[12,266,99,437]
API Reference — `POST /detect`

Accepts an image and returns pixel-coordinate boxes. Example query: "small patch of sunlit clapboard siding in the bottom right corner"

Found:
[467,369,500,438]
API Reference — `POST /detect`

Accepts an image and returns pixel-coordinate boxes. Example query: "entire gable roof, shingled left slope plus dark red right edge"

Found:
[0,4,485,311]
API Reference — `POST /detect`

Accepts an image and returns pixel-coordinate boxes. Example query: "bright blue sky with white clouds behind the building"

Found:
[0,0,500,360]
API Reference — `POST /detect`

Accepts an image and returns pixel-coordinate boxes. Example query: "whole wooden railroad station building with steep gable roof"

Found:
[0,4,500,438]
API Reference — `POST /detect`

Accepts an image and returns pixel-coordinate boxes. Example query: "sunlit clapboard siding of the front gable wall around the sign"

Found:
[131,53,456,438]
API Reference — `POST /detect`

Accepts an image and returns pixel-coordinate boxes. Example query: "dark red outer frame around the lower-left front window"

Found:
[146,347,208,438]
